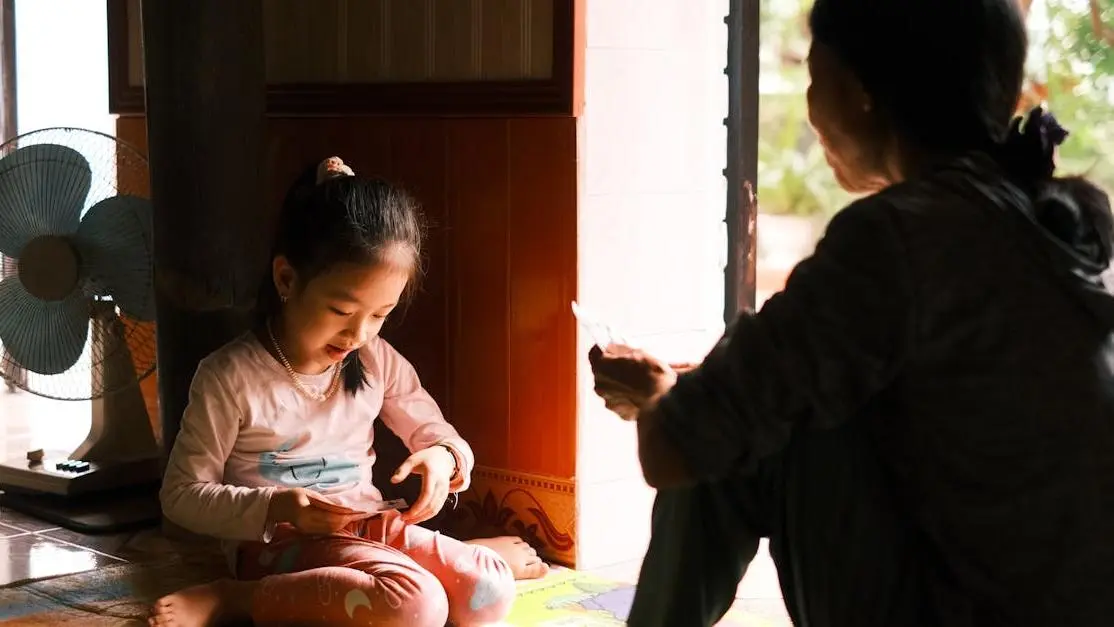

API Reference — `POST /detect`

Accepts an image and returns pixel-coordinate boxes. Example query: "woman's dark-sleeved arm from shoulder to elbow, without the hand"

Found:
[638,198,915,488]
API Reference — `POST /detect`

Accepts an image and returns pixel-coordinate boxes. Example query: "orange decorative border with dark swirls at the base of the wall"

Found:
[444,466,576,566]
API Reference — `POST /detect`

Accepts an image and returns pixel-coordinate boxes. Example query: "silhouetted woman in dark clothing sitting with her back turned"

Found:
[589,0,1114,627]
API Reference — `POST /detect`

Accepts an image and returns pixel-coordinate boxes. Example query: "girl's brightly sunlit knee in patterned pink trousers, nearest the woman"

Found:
[444,547,516,627]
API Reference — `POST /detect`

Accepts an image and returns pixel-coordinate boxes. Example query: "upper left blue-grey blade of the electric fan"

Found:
[0,144,92,258]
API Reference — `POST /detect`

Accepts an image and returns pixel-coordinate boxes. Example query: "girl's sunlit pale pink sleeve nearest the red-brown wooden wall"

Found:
[372,340,476,492]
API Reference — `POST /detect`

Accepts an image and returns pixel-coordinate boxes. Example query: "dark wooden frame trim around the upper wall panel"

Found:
[106,0,584,116]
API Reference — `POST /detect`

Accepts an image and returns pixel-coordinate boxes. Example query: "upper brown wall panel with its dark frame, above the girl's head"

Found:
[105,0,584,116]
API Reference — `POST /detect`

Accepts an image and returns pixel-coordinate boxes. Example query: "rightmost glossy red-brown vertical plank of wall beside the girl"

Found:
[507,119,577,474]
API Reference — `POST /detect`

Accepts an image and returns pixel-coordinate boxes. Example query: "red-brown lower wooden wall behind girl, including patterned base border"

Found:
[117,117,577,562]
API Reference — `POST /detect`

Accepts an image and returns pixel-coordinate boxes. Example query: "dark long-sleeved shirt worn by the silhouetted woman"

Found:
[661,156,1114,627]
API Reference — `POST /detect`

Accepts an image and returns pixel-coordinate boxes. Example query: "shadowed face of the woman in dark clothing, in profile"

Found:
[807,41,890,193]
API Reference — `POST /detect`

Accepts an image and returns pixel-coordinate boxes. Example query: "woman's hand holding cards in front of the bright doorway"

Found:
[588,344,693,420]
